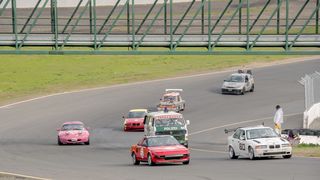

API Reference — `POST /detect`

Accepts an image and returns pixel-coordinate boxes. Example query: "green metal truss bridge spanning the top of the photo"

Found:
[0,0,320,55]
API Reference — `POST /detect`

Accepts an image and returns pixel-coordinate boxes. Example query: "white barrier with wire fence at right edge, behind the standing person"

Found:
[300,72,320,129]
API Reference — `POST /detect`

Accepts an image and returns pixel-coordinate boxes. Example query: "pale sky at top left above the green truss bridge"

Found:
[0,0,198,8]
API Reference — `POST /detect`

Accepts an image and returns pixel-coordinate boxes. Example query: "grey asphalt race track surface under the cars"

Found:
[0,60,320,180]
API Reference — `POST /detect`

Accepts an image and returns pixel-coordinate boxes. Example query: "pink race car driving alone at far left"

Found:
[57,121,90,145]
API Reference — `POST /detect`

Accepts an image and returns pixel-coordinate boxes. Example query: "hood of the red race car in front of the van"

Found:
[149,145,189,155]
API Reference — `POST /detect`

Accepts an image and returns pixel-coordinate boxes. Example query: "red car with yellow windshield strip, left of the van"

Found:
[123,109,148,131]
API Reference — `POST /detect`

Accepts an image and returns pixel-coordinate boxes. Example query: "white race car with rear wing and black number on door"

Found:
[228,126,292,160]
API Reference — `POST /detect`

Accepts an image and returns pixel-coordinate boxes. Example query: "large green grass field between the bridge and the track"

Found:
[0,55,304,104]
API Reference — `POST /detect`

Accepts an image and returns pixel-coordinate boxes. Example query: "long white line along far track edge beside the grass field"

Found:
[0,56,320,109]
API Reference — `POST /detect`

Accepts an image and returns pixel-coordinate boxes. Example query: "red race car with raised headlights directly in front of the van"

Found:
[130,135,190,166]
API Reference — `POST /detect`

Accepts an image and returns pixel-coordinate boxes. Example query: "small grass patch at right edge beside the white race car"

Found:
[293,144,320,157]
